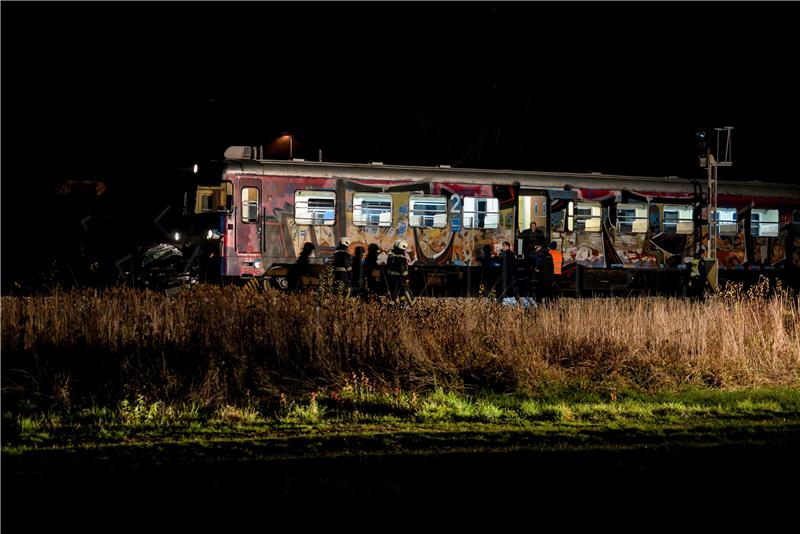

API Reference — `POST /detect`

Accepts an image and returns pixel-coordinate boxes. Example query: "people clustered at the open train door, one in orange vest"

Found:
[479,222,562,302]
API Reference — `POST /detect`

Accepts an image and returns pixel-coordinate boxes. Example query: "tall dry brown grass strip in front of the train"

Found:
[2,280,800,408]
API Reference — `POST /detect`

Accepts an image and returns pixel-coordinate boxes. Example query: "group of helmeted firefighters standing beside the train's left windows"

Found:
[289,237,413,302]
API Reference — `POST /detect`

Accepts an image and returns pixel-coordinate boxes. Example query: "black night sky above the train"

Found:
[2,2,800,284]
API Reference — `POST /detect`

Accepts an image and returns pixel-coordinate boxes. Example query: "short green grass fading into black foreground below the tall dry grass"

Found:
[3,390,800,530]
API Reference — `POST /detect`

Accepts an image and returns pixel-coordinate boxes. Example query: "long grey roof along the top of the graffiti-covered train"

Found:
[219,159,800,200]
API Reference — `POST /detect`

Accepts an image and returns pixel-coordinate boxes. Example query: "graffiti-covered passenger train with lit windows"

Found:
[187,151,800,295]
